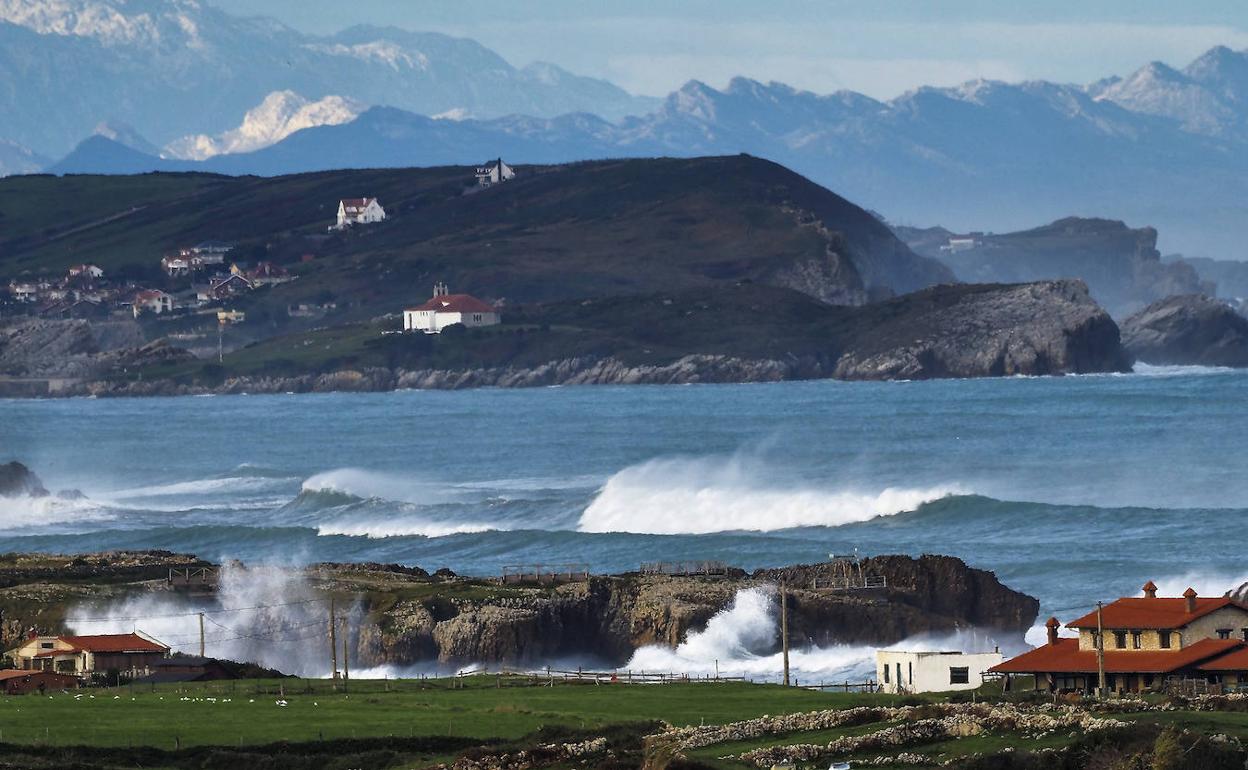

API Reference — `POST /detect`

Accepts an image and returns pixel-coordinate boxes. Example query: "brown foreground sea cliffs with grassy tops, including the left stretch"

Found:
[0,552,1038,666]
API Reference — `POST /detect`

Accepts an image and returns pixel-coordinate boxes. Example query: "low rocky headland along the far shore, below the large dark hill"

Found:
[71,281,1131,396]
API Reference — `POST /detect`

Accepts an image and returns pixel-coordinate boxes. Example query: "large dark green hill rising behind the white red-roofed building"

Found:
[0,156,951,321]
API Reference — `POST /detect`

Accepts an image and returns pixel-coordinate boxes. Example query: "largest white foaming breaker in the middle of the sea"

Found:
[578,457,966,534]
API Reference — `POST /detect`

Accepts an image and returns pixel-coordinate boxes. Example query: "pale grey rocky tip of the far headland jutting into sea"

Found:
[832,281,1131,379]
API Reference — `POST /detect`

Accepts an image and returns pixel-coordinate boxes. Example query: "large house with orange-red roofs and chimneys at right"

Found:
[990,580,1248,693]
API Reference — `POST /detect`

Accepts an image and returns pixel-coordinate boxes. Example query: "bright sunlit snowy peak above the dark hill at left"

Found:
[162,91,364,161]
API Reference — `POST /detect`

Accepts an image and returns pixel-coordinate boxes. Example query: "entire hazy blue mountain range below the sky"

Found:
[7,0,1248,260]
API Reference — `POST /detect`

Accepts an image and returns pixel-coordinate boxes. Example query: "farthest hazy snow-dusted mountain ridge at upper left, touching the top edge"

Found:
[0,0,655,155]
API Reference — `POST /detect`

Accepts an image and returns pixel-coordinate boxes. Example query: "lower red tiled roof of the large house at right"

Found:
[988,639,1244,674]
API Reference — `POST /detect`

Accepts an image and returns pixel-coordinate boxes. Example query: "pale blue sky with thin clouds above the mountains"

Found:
[210,0,1248,99]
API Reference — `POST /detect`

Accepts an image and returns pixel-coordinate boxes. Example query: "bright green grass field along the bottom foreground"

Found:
[0,675,1248,770]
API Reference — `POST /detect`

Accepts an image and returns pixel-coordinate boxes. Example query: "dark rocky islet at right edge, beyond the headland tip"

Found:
[1122,295,1248,367]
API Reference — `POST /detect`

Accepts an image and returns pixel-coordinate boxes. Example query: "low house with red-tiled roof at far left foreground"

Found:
[6,633,170,678]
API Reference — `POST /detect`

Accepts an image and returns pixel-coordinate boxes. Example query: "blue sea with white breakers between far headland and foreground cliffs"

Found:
[0,366,1248,675]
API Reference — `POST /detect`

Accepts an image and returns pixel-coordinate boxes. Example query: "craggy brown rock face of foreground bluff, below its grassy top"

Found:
[343,557,1038,665]
